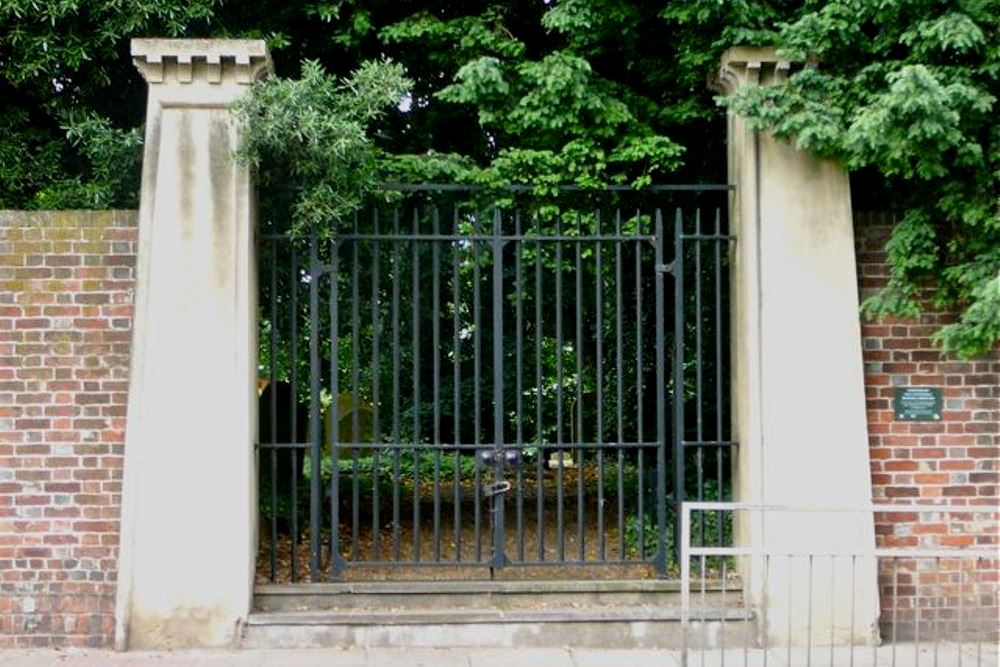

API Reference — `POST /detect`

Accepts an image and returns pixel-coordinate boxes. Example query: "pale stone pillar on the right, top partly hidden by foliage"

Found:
[718,48,878,646]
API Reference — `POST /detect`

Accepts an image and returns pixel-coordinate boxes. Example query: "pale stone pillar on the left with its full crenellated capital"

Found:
[115,39,271,649]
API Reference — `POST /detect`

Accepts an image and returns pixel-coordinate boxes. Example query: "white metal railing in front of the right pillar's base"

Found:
[679,502,1000,667]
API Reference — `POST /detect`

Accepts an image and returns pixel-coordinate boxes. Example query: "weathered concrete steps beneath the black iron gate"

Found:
[242,581,753,648]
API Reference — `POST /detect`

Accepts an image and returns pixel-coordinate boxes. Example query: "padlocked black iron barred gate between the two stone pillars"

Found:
[259,186,733,581]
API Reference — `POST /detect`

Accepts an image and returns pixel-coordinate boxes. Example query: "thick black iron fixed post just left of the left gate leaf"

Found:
[309,228,323,582]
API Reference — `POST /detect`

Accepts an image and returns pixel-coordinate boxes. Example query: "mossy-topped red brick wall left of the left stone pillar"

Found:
[0,211,137,647]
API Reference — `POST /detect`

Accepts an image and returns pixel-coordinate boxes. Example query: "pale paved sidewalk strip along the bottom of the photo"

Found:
[0,644,998,667]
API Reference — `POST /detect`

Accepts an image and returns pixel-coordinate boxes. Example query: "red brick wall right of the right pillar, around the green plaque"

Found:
[855,214,1000,639]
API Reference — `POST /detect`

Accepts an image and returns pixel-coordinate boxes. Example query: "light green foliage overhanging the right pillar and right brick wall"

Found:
[721,0,1000,357]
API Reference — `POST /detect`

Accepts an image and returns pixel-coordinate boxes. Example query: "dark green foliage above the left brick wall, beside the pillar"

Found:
[0,0,216,208]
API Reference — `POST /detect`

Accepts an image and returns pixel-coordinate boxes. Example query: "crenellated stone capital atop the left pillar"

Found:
[132,39,272,97]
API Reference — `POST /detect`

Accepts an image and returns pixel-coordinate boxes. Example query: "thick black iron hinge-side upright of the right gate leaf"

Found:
[656,209,668,577]
